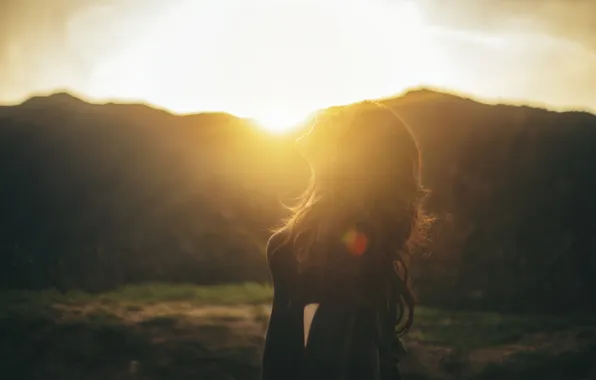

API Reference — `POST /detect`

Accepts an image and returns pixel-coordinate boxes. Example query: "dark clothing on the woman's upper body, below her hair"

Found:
[263,230,399,380]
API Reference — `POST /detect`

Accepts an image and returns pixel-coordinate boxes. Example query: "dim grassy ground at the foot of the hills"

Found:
[0,284,596,380]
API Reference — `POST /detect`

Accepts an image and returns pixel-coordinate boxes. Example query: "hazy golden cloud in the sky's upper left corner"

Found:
[0,0,159,99]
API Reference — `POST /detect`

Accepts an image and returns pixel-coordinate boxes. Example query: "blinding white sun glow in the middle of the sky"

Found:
[70,0,438,123]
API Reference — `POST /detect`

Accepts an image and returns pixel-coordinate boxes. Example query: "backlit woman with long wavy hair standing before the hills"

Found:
[263,102,424,380]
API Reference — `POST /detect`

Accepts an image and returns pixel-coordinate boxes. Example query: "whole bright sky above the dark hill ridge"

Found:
[0,0,596,129]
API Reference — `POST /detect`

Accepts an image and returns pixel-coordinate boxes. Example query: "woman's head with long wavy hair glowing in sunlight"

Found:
[278,101,426,335]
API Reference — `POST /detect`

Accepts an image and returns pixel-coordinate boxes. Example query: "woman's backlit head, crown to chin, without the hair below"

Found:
[296,101,420,186]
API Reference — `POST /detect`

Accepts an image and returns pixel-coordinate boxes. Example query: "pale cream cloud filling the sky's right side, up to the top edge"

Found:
[400,0,596,110]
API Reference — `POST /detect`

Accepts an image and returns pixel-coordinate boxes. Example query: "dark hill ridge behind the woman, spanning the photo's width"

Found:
[0,89,596,311]
